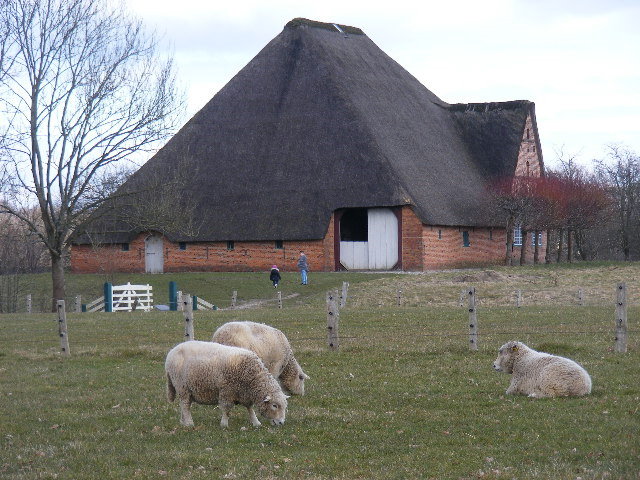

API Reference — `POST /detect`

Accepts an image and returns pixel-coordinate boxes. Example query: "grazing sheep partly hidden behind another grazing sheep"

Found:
[211,322,309,395]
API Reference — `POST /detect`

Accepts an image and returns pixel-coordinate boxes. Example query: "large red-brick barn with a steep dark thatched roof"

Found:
[71,19,542,272]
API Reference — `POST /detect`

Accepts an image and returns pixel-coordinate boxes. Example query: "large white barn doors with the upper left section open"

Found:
[340,208,398,270]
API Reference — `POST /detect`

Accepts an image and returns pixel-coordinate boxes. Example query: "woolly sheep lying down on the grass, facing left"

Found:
[493,341,591,398]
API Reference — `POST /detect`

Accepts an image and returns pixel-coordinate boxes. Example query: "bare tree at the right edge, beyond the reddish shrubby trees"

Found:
[596,145,640,260]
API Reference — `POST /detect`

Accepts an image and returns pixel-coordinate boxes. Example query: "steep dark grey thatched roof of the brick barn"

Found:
[77,19,535,241]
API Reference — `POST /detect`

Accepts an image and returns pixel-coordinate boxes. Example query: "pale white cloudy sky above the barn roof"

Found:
[127,0,640,166]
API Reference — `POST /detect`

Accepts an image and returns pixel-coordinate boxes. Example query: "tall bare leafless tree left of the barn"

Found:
[0,0,183,307]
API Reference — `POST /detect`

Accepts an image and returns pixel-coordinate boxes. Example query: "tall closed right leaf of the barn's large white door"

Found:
[367,208,398,270]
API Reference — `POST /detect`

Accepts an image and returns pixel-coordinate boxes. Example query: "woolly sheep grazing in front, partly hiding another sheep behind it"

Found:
[165,340,287,427]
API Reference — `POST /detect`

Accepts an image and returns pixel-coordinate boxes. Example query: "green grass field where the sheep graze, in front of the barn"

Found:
[0,265,640,479]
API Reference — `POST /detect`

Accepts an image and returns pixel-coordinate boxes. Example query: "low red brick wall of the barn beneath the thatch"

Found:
[71,210,546,273]
